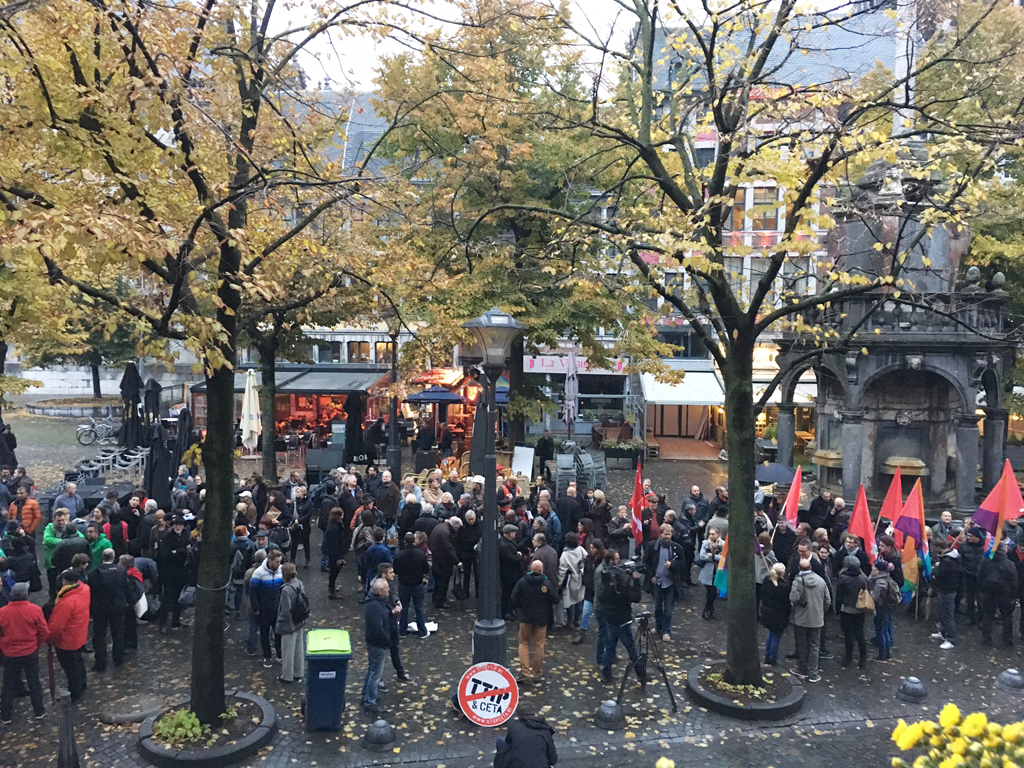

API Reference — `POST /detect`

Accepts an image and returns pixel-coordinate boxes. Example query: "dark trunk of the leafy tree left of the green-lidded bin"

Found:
[191,366,234,726]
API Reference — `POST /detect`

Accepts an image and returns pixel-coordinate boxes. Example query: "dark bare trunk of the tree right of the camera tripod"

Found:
[723,329,763,686]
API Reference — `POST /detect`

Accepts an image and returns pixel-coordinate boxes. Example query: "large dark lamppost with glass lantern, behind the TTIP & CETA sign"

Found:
[462,307,525,666]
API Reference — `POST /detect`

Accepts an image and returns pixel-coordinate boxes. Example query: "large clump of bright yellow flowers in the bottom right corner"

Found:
[892,703,1024,768]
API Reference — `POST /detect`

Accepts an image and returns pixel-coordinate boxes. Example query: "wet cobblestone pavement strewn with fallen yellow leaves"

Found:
[0,462,1022,768]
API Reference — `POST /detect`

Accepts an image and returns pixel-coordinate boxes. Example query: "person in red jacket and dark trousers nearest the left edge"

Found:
[0,582,50,725]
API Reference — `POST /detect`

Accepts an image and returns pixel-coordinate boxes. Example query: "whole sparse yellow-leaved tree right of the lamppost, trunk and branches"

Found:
[456,0,1021,684]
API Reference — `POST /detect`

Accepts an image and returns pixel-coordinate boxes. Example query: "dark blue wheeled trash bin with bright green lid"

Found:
[306,630,352,731]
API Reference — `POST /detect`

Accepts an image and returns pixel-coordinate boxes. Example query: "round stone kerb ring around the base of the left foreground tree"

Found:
[137,690,278,768]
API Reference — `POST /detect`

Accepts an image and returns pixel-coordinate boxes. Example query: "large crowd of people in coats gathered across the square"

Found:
[8,444,1024,768]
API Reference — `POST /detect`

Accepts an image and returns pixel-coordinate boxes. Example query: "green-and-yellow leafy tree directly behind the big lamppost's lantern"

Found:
[375,0,640,442]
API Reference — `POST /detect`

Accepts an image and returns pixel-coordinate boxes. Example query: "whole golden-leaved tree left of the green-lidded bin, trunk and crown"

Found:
[0,0,407,724]
